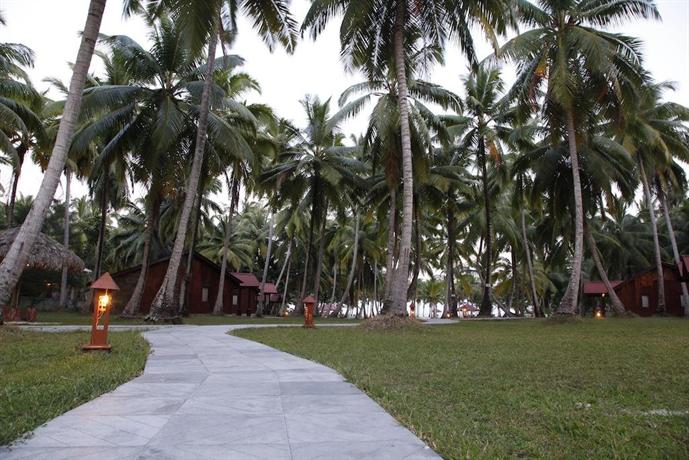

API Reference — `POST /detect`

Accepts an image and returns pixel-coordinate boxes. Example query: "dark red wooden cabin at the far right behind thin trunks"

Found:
[584,264,684,316]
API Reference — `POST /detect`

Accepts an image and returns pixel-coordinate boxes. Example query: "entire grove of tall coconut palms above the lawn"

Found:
[0,0,689,320]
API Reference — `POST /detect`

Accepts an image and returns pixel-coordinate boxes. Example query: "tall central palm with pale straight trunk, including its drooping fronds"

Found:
[302,0,508,315]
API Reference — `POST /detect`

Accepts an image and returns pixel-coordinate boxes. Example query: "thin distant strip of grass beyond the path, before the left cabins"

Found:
[26,311,353,326]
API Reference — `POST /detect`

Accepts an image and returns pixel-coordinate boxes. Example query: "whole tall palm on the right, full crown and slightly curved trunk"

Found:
[497,0,659,315]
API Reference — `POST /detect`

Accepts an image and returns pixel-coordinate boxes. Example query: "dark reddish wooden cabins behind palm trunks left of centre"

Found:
[112,252,258,315]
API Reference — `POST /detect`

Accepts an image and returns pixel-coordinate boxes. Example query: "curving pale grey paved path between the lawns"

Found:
[0,326,439,460]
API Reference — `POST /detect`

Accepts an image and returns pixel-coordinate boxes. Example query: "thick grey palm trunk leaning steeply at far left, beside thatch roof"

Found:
[0,0,106,310]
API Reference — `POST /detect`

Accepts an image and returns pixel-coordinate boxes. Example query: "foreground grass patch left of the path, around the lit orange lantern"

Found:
[0,326,148,445]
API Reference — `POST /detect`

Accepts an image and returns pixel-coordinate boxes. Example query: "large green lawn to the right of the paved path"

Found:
[235,318,689,459]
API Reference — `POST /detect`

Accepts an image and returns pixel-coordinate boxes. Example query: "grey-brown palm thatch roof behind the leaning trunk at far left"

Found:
[0,227,84,272]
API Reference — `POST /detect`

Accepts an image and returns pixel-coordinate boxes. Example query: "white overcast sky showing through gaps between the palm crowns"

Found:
[0,0,689,206]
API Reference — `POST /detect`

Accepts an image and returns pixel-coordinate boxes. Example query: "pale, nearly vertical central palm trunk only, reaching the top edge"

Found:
[391,1,414,316]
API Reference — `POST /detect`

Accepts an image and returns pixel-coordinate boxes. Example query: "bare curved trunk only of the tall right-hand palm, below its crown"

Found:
[555,108,584,316]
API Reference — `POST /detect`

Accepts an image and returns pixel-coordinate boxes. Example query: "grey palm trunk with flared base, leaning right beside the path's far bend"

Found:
[147,25,218,321]
